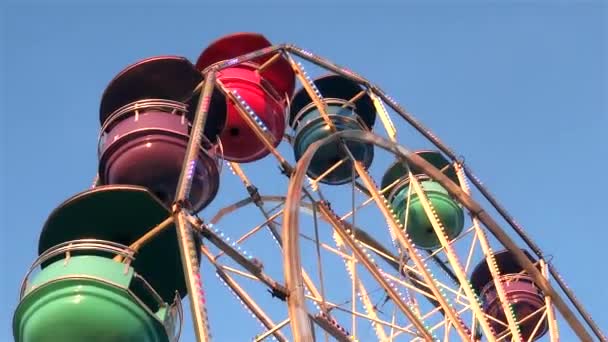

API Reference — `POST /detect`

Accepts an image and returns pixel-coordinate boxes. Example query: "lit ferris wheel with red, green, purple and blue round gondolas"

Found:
[13,33,606,342]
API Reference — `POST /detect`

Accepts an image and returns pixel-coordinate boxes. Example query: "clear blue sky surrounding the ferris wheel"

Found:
[0,0,608,341]
